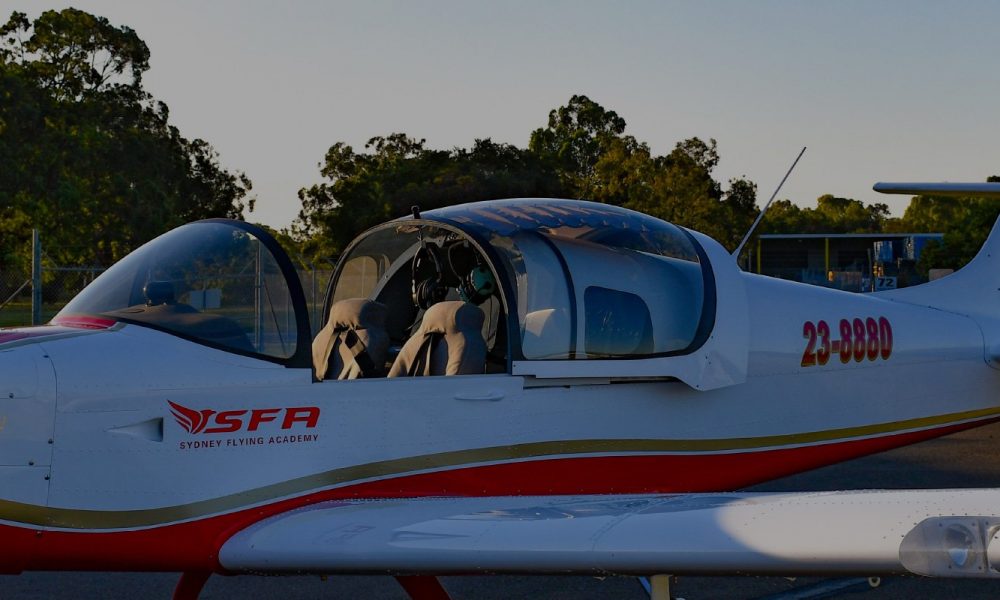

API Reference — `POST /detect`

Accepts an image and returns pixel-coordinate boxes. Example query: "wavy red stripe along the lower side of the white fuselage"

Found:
[0,418,1000,573]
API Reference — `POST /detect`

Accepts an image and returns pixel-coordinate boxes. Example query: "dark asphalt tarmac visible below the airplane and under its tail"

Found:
[0,424,1000,600]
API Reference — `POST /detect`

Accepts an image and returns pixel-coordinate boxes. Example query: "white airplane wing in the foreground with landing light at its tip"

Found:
[219,489,1000,577]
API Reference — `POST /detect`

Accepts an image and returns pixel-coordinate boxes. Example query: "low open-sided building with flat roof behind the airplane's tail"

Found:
[749,233,944,292]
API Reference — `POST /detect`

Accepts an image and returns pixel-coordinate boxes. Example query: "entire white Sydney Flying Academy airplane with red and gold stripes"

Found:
[0,184,1000,600]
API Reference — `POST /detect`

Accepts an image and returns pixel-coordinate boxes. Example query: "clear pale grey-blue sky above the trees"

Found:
[9,0,1000,228]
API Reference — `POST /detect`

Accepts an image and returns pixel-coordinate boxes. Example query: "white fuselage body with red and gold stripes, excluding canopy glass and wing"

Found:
[0,196,1000,584]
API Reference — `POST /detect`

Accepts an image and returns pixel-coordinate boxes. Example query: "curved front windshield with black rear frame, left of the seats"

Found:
[54,219,310,367]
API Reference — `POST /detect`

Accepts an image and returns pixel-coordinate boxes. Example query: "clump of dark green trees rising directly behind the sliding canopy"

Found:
[293,95,757,255]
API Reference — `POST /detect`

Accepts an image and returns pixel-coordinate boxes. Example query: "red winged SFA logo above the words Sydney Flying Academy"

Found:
[167,400,319,433]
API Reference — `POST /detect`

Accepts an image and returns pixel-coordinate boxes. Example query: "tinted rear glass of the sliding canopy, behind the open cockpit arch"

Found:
[433,199,712,360]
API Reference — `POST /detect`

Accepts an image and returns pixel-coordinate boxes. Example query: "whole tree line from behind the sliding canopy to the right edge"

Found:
[292,95,1000,270]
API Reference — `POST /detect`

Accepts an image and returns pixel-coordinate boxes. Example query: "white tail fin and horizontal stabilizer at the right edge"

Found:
[874,183,1000,317]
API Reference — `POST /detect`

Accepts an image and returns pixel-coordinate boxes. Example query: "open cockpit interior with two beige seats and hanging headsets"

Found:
[313,223,508,379]
